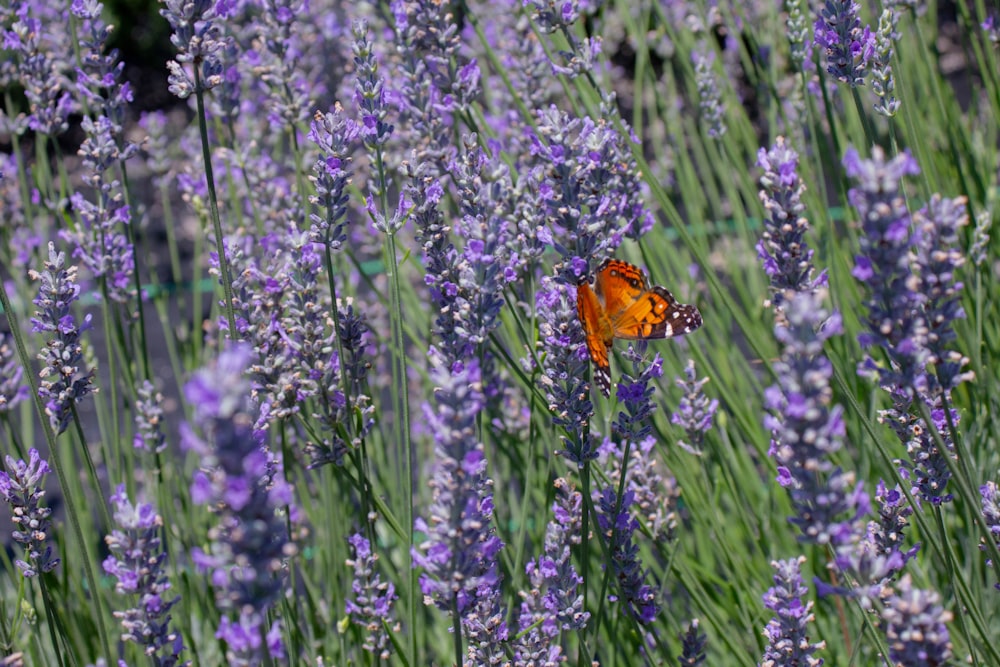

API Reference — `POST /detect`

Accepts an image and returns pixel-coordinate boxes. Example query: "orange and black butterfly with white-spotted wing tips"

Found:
[576,259,701,397]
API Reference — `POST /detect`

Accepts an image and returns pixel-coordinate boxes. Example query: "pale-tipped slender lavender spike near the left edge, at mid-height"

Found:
[28,243,94,435]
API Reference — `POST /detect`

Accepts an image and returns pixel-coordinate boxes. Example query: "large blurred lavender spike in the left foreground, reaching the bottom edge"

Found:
[184,343,292,664]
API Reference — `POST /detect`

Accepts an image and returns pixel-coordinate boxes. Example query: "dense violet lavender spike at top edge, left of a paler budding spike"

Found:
[813,0,875,87]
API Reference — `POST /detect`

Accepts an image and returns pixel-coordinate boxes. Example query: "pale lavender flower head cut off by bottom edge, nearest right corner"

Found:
[882,575,952,667]
